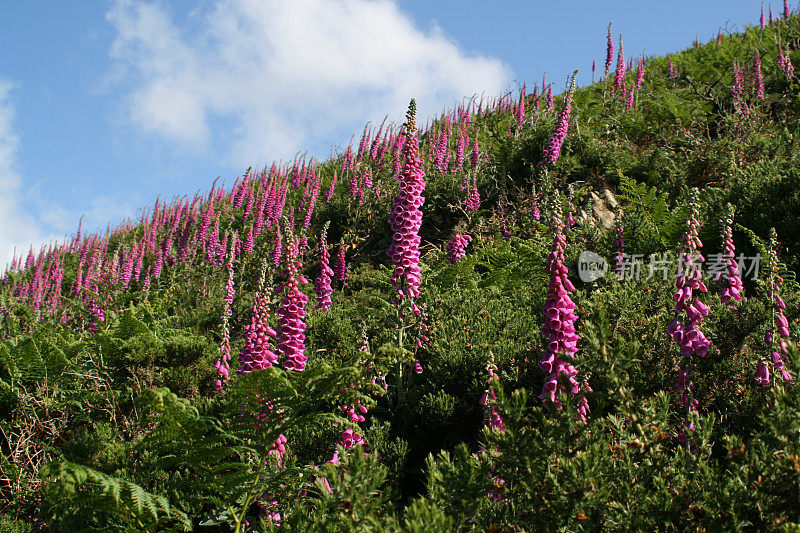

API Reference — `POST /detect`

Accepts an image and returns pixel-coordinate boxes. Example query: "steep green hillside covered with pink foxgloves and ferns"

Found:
[0,8,800,532]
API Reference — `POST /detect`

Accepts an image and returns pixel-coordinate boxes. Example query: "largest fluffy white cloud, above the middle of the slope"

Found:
[107,0,511,166]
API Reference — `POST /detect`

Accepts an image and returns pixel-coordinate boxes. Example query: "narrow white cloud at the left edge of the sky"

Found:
[0,79,55,269]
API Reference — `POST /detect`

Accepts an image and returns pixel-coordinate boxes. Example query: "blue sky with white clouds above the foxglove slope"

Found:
[0,0,776,265]
